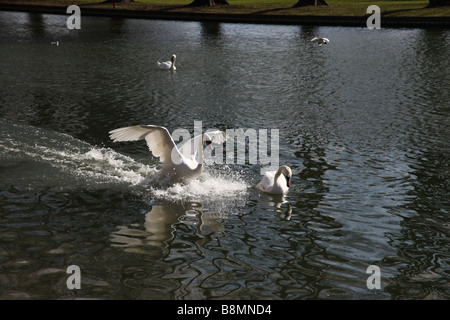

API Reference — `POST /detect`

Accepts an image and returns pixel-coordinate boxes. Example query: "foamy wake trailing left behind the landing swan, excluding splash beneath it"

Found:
[0,121,156,188]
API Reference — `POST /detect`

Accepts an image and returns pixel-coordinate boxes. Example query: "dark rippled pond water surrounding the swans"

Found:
[0,12,450,300]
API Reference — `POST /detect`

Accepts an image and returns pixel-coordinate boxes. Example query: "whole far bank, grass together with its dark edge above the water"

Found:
[0,0,450,27]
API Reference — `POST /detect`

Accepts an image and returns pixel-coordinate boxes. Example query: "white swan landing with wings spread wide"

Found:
[109,125,226,184]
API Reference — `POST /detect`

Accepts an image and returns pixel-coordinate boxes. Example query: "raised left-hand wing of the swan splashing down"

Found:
[109,125,179,164]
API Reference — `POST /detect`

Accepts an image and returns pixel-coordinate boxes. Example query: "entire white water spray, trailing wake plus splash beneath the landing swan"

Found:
[0,121,249,202]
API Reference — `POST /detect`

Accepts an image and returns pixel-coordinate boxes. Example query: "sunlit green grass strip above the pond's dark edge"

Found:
[0,0,450,18]
